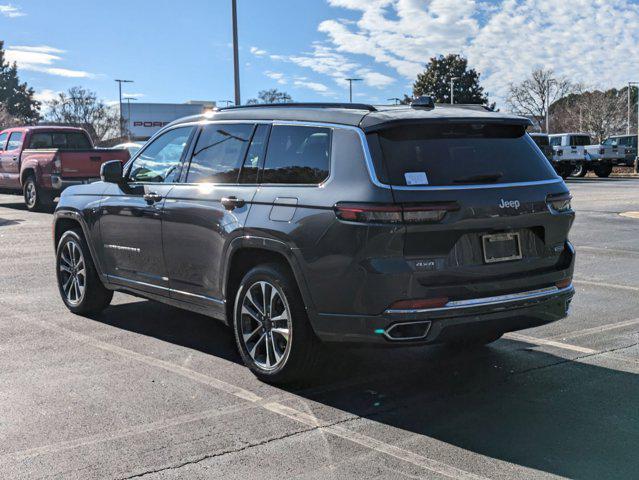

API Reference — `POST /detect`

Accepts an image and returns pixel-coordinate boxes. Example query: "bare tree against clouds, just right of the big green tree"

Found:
[507,68,577,131]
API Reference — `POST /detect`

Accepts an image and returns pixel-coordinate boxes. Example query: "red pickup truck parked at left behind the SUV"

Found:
[0,126,129,210]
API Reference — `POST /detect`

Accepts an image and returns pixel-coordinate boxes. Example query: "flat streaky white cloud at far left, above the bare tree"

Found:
[5,45,95,78]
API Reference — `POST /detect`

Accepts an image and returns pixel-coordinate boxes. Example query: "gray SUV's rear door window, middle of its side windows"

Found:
[186,123,255,183]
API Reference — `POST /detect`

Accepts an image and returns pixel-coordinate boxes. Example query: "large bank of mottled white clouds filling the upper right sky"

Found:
[320,0,639,104]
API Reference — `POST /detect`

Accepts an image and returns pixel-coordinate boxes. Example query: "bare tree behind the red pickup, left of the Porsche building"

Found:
[45,87,120,143]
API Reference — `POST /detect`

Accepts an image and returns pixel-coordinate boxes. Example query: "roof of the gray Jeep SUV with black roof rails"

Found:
[173,103,530,129]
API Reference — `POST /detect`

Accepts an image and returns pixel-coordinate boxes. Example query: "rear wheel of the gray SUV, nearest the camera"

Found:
[233,263,320,384]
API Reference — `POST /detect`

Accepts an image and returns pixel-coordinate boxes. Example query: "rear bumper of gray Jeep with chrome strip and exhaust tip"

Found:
[312,285,575,345]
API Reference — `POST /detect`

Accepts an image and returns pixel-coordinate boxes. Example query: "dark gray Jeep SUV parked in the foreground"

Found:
[54,99,575,382]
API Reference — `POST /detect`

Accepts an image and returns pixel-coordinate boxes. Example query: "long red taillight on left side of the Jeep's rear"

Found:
[334,202,459,223]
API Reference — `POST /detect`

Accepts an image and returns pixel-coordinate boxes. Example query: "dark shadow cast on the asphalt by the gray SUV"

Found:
[98,302,639,480]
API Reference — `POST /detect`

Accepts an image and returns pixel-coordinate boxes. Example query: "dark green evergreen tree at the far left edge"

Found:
[0,40,40,124]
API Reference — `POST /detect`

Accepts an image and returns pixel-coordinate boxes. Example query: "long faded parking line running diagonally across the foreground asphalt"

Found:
[0,308,486,480]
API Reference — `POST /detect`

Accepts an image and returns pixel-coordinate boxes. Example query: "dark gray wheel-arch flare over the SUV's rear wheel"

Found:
[221,235,315,313]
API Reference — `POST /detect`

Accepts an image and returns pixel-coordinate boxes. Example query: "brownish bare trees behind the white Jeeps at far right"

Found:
[551,89,627,142]
